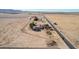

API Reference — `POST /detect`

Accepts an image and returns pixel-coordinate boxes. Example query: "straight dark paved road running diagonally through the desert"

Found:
[43,16,76,49]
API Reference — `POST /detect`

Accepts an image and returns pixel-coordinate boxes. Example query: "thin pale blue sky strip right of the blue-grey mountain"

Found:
[23,9,79,12]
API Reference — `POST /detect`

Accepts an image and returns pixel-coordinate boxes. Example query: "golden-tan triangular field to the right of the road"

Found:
[45,14,79,48]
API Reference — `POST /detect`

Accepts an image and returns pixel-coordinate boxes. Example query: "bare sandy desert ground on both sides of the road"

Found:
[0,13,79,49]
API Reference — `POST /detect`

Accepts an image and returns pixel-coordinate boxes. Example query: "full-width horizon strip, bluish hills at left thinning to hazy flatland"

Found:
[0,9,79,14]
